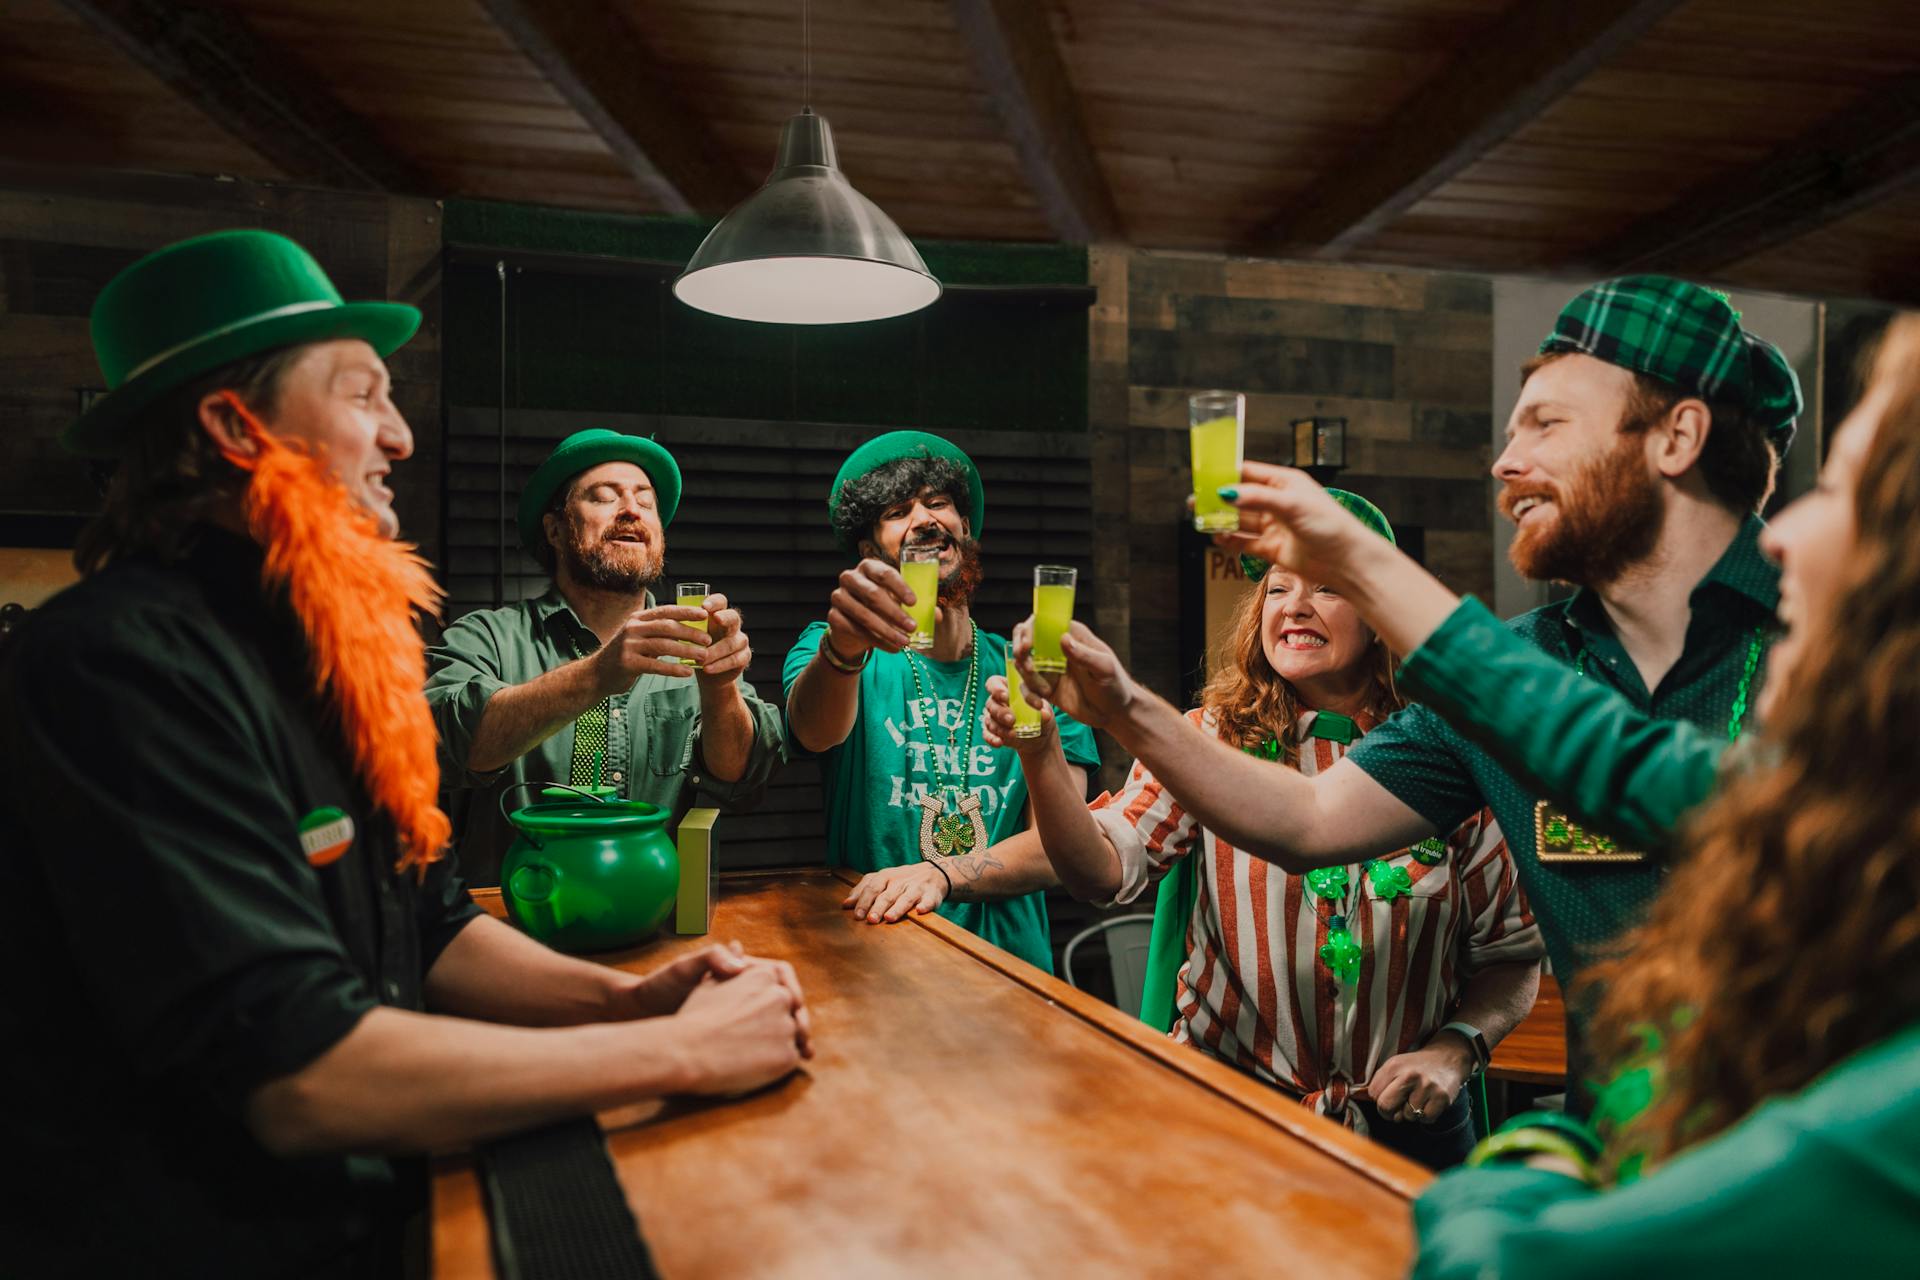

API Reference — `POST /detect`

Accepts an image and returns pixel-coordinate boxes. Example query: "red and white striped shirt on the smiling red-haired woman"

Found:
[1092,710,1546,1128]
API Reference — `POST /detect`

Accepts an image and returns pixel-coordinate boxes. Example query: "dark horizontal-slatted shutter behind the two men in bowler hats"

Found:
[444,407,1092,867]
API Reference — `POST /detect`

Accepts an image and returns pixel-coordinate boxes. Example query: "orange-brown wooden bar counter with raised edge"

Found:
[434,871,1428,1280]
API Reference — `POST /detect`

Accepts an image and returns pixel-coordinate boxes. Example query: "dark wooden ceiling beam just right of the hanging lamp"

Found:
[952,0,1127,244]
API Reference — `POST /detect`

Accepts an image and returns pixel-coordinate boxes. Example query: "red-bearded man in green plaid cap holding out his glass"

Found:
[1006,276,1799,1105]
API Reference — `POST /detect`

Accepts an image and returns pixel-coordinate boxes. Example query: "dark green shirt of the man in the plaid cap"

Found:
[1348,518,1780,984]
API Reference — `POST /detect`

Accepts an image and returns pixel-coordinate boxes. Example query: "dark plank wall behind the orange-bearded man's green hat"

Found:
[0,165,440,558]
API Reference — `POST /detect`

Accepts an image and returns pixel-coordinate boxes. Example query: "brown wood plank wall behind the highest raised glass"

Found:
[1089,249,1494,717]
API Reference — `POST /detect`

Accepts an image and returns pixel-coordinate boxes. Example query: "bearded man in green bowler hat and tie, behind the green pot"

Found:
[426,428,785,885]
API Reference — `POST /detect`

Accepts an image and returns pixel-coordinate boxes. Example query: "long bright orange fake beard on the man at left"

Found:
[221,391,453,871]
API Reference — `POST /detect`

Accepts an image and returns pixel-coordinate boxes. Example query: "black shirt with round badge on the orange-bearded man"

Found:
[0,530,476,1276]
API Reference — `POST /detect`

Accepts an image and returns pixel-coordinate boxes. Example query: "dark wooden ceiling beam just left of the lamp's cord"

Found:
[480,0,752,215]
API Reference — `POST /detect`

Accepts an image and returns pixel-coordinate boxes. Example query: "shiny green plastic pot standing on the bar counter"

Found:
[499,783,680,954]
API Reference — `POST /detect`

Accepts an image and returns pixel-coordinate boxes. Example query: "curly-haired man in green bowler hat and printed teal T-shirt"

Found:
[781,432,1100,973]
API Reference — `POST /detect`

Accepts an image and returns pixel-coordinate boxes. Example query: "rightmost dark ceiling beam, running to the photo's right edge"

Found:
[1592,73,1920,274]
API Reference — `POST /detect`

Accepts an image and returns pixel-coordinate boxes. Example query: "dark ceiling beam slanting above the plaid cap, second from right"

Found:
[1250,0,1684,259]
